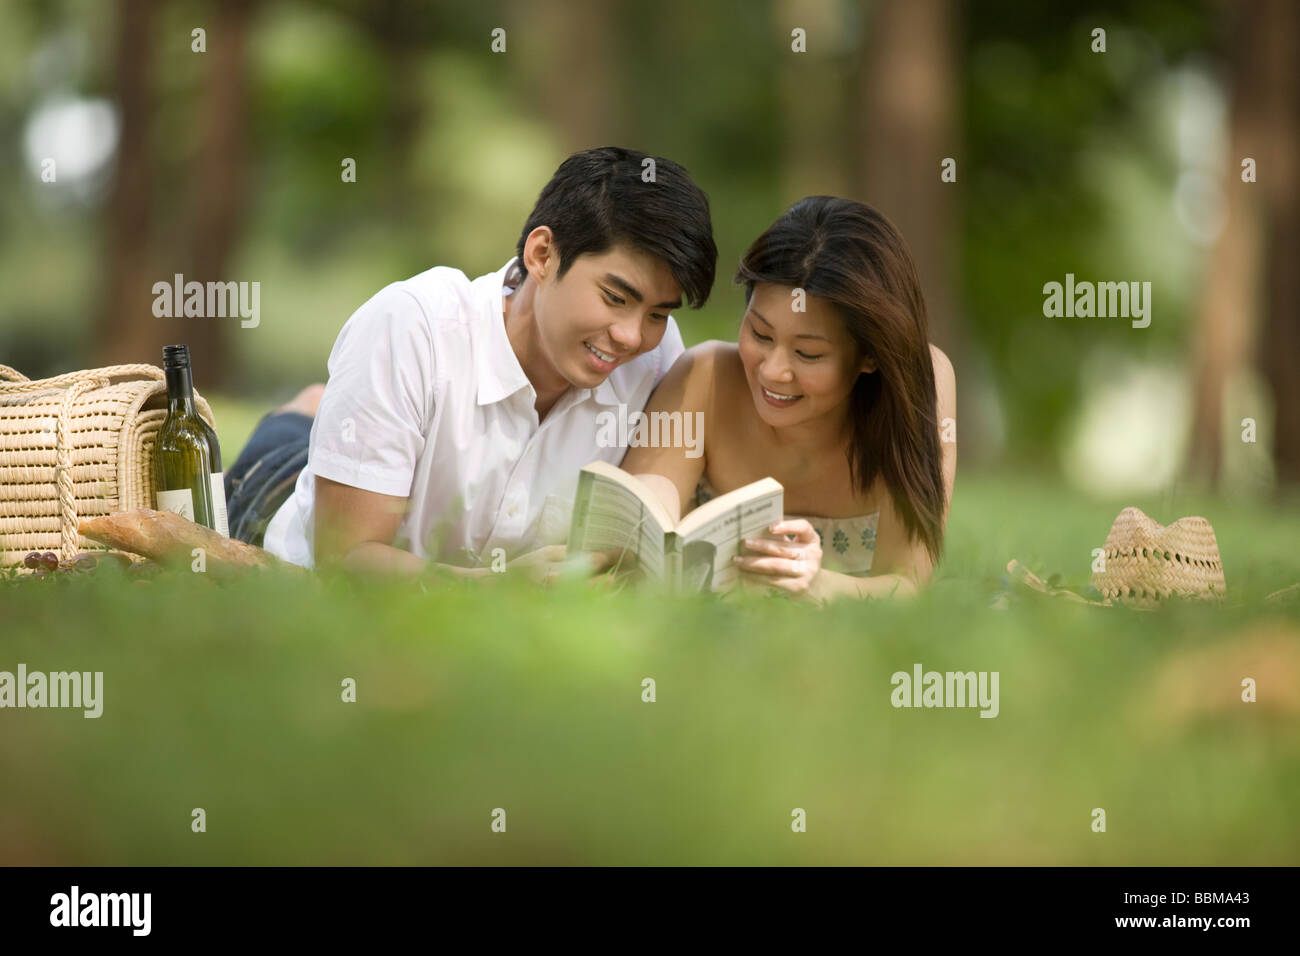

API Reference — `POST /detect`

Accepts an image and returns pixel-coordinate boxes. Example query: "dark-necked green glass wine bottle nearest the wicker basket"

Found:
[153,345,217,531]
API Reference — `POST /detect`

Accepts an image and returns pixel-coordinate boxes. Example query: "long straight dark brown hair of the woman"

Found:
[736,196,945,563]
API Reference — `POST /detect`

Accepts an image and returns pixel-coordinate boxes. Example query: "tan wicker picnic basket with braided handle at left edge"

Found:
[0,365,216,567]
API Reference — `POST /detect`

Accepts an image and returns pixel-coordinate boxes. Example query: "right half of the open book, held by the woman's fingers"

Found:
[677,479,785,591]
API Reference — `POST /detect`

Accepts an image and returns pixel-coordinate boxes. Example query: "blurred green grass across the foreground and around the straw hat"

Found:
[0,475,1300,865]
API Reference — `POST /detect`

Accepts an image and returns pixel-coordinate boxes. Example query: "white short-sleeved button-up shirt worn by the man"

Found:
[264,259,684,567]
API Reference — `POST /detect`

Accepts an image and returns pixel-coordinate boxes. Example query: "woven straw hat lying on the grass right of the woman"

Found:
[1092,507,1226,607]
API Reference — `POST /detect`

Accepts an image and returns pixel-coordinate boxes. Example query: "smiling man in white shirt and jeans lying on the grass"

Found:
[228,147,718,575]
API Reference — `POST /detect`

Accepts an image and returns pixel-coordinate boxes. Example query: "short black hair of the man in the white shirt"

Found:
[517,146,718,308]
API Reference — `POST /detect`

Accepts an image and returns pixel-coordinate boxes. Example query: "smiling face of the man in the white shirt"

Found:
[533,245,681,389]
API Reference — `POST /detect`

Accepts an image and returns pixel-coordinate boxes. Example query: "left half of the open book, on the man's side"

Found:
[568,462,667,581]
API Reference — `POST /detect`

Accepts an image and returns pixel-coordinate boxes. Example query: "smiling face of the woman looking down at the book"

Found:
[740,282,875,428]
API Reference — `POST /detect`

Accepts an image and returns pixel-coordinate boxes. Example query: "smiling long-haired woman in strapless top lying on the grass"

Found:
[623,196,957,601]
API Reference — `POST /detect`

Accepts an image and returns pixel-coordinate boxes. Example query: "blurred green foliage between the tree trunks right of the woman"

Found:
[961,3,1221,458]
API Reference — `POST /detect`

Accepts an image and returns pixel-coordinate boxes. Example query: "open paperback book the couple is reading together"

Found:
[568,462,785,591]
